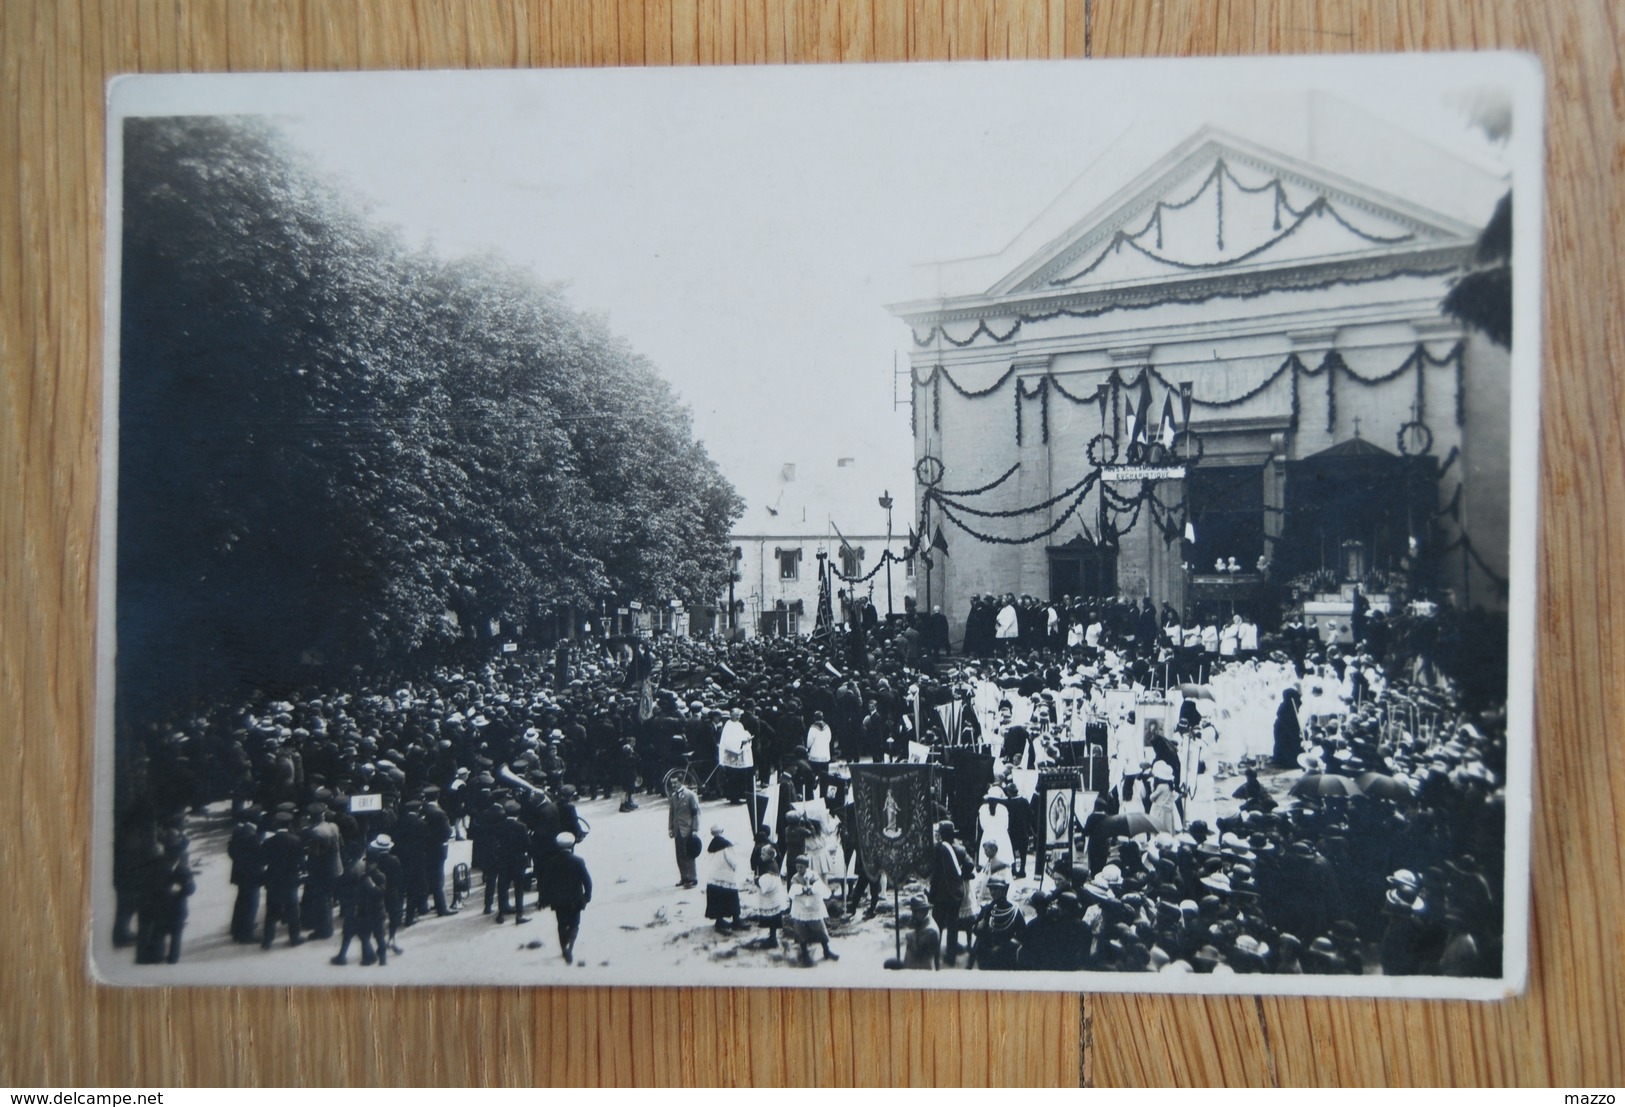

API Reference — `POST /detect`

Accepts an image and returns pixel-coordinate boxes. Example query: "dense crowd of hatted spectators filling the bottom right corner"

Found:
[1022,708,1503,975]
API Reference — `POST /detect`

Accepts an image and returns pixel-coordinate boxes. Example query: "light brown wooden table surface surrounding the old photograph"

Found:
[0,0,1625,1089]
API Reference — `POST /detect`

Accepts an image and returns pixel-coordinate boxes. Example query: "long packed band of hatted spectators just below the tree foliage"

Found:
[132,626,962,818]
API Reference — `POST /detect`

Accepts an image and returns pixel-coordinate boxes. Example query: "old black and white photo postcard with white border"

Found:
[86,54,1542,1000]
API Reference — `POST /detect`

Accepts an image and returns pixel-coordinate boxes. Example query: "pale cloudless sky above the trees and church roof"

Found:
[114,55,1498,523]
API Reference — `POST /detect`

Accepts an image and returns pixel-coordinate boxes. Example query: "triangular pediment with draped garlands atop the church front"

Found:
[990,130,1476,296]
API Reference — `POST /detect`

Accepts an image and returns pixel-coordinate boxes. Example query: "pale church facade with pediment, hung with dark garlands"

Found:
[892,121,1510,643]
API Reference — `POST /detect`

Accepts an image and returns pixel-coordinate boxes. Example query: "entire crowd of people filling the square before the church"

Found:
[114,578,1506,975]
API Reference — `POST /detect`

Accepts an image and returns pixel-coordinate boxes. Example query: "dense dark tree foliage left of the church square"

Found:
[119,117,743,711]
